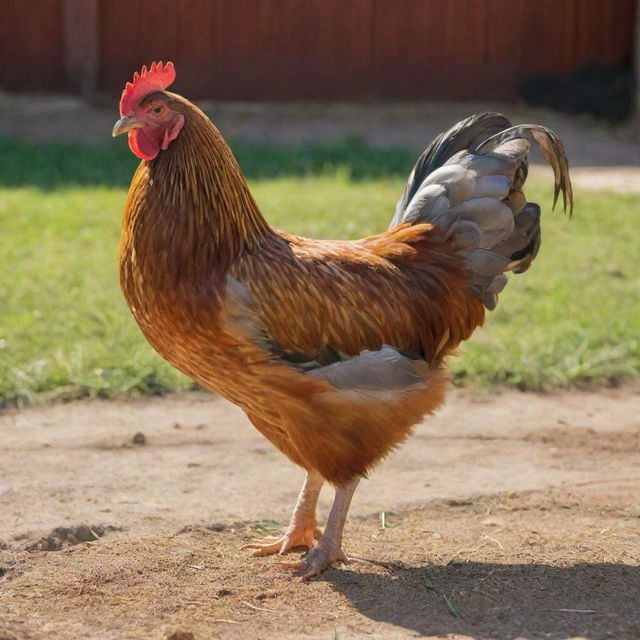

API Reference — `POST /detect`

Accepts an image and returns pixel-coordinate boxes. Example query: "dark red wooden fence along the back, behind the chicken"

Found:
[0,0,636,100]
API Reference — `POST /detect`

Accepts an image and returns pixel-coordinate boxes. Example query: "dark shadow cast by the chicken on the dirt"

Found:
[321,562,640,640]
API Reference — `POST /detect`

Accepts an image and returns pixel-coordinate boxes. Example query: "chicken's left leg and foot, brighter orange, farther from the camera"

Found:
[242,471,324,556]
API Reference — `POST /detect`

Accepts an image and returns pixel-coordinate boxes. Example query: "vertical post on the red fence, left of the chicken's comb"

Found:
[62,0,99,101]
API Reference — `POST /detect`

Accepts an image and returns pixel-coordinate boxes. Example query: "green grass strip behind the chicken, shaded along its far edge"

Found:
[0,136,640,405]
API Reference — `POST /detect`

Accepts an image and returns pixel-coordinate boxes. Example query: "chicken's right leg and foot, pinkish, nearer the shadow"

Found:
[283,478,360,580]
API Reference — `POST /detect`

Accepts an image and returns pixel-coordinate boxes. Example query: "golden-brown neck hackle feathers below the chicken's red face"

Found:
[121,101,274,302]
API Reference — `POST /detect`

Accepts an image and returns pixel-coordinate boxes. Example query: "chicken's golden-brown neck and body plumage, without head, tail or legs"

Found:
[115,94,484,483]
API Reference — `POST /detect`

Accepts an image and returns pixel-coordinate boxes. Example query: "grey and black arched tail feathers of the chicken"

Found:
[392,114,573,309]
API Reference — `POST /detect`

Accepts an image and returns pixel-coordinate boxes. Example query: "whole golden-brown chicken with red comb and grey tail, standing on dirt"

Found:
[113,63,572,578]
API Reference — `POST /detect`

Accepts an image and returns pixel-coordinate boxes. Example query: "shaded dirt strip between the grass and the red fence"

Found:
[0,92,640,193]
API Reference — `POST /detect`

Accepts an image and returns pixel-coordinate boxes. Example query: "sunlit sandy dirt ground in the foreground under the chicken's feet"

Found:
[0,388,640,640]
